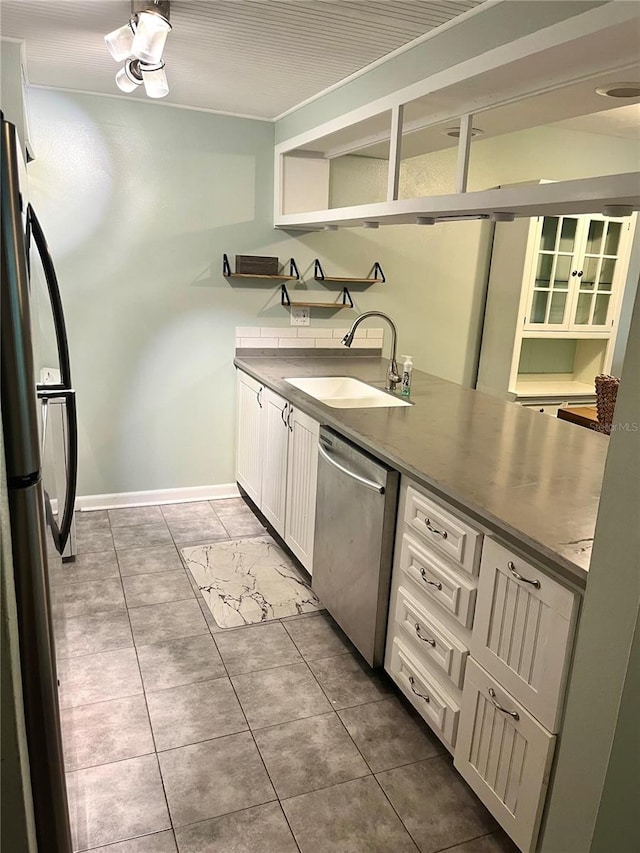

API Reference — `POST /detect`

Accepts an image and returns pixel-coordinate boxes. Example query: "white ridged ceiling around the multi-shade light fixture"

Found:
[0,0,484,119]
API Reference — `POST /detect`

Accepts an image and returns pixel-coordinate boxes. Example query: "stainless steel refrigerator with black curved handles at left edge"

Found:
[0,114,77,853]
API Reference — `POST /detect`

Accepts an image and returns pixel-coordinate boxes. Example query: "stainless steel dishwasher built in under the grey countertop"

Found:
[311,427,400,667]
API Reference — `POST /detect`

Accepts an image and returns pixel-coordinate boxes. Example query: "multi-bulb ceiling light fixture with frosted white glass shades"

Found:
[104,0,171,98]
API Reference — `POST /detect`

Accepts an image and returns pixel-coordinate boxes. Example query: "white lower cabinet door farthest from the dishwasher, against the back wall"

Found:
[236,371,265,506]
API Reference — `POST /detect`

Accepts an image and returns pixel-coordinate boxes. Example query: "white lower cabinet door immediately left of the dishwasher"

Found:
[284,408,320,574]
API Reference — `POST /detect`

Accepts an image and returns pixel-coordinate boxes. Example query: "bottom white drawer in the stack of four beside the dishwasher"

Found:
[388,638,460,749]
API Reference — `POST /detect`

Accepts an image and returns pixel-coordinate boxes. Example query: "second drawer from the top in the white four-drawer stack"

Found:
[400,533,476,627]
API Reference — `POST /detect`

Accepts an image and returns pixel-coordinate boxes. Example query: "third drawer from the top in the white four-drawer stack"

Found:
[395,586,469,687]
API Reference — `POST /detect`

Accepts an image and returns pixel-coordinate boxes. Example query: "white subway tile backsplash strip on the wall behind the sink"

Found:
[236,326,384,352]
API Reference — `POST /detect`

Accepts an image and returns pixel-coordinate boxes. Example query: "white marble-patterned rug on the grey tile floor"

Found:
[180,536,322,628]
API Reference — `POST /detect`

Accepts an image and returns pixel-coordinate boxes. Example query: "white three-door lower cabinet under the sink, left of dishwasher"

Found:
[236,370,320,573]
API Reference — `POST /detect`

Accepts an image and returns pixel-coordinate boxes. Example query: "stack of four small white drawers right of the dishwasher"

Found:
[384,478,482,752]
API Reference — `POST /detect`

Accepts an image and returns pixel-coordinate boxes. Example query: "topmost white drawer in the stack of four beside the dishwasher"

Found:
[404,486,482,575]
